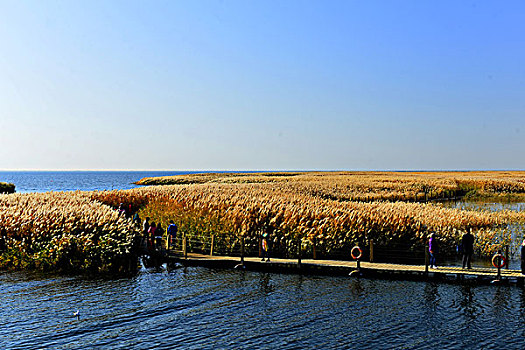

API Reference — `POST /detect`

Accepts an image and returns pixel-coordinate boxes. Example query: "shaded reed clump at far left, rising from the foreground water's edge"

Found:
[0,192,138,272]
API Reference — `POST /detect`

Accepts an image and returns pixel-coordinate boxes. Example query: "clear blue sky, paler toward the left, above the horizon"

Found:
[0,0,525,170]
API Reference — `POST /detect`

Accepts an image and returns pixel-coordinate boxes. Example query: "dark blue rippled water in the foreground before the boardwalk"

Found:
[4,267,525,349]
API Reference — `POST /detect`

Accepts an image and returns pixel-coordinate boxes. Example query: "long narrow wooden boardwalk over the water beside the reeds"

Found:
[161,251,525,286]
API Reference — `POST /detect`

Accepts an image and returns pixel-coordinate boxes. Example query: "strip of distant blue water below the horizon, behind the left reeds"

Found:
[0,171,198,193]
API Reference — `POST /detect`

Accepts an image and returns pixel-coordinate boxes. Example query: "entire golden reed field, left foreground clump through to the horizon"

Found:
[0,172,525,271]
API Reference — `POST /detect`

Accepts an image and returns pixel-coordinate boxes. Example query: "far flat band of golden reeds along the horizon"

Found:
[138,171,525,202]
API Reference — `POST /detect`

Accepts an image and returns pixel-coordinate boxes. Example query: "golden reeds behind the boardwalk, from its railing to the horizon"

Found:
[134,172,525,255]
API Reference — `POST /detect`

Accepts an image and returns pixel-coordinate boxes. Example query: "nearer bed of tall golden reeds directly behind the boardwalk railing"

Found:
[100,181,525,255]
